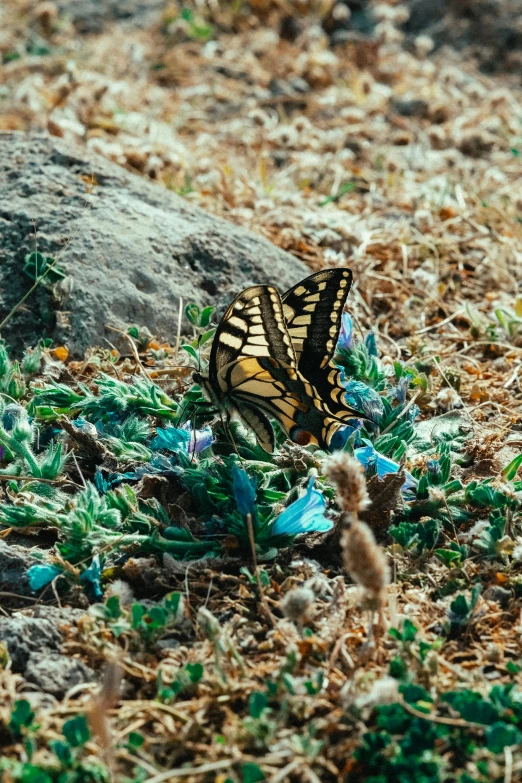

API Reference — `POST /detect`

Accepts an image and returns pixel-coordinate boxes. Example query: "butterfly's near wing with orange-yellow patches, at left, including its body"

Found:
[194,281,366,453]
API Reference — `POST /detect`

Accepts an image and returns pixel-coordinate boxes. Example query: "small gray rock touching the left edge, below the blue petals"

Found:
[0,615,62,674]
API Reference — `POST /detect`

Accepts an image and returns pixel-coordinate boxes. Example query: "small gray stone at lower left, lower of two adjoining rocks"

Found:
[24,653,97,699]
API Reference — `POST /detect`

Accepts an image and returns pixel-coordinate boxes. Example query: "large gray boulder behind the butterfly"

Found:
[0,132,310,356]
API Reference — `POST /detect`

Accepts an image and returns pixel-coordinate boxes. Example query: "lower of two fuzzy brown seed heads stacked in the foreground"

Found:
[341,520,390,609]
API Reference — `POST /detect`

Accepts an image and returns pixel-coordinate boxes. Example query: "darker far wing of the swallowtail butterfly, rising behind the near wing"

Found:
[281,268,354,420]
